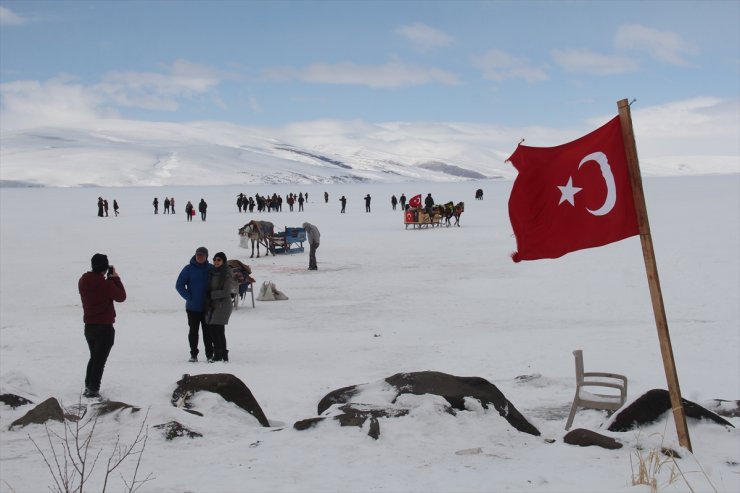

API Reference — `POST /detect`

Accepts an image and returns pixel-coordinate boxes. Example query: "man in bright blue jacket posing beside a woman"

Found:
[175,247,213,363]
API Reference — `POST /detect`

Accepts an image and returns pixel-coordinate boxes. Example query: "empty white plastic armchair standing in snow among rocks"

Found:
[565,349,627,430]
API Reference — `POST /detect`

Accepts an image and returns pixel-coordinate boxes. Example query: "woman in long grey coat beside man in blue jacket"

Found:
[206,252,233,363]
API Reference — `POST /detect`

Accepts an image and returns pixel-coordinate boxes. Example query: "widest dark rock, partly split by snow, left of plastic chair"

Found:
[318,371,540,436]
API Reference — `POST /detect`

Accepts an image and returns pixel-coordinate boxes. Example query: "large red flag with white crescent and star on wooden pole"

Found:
[507,116,639,262]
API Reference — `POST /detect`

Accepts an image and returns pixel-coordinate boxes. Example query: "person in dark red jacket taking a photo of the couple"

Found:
[77,253,126,399]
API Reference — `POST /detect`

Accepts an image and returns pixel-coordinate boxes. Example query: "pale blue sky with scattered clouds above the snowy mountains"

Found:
[0,0,740,127]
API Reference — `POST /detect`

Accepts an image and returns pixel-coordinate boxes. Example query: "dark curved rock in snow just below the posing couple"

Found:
[170,373,270,427]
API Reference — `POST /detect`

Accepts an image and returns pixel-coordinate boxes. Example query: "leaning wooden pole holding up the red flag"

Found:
[617,99,691,451]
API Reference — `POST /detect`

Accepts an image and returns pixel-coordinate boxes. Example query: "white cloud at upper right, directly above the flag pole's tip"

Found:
[614,24,698,66]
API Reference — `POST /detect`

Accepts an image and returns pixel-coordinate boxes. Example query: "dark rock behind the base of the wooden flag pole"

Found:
[608,389,734,431]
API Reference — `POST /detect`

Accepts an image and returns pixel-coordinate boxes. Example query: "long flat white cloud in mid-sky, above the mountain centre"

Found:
[263,62,460,88]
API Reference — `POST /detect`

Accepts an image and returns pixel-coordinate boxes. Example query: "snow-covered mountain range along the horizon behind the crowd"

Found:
[0,120,737,187]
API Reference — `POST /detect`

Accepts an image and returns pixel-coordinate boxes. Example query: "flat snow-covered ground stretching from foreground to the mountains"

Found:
[0,178,740,493]
